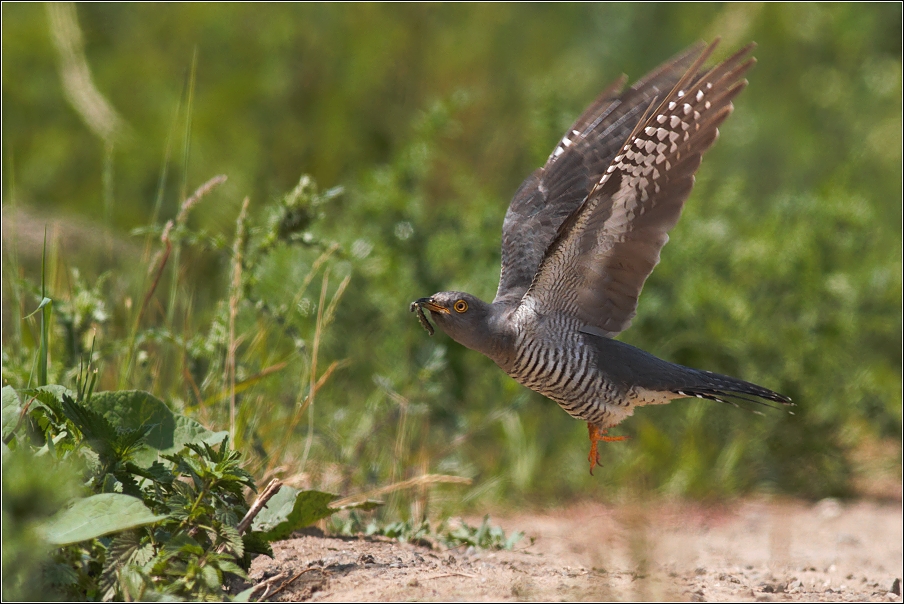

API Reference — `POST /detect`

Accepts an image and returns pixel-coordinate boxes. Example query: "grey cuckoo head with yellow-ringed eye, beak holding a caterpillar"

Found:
[411,292,493,354]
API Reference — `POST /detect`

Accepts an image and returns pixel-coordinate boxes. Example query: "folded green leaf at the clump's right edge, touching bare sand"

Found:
[252,486,336,541]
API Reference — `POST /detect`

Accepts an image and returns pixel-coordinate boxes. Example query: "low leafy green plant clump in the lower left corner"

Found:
[2,386,376,601]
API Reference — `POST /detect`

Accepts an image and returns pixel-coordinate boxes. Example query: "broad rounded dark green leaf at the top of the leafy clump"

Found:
[91,390,228,467]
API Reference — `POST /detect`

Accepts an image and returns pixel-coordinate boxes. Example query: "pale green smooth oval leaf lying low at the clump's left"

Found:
[42,493,166,545]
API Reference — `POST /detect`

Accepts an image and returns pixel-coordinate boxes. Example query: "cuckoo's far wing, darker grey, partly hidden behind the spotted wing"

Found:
[495,44,703,304]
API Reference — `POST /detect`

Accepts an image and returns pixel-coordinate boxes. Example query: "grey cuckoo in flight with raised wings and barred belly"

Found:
[411,43,790,472]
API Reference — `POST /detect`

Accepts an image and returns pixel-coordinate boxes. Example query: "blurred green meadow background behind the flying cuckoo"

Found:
[2,3,902,515]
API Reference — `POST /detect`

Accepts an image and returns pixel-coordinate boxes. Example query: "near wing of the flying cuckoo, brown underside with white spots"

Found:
[522,43,755,337]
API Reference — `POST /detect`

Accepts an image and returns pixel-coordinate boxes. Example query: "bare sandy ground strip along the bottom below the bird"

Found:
[251,500,904,602]
